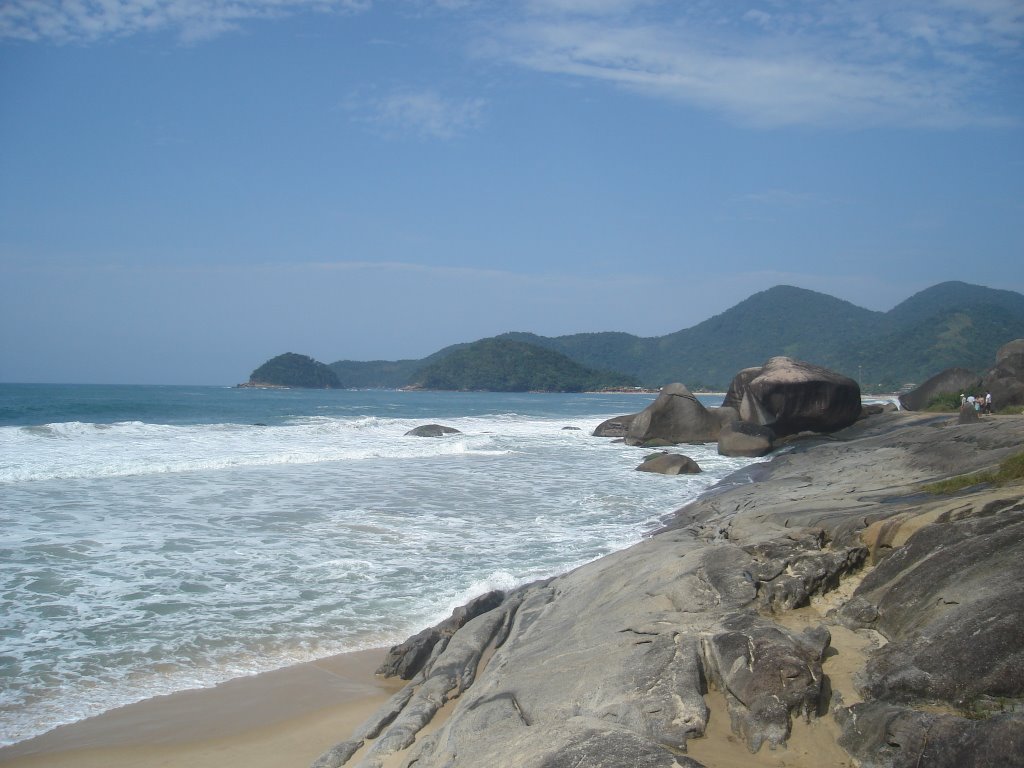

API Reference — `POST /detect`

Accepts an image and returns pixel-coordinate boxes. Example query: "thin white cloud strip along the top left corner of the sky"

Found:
[0,0,371,43]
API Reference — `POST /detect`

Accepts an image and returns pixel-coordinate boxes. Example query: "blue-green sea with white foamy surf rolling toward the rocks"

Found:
[0,385,752,744]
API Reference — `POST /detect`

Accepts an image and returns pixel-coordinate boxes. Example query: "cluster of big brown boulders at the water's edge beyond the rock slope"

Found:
[594,356,860,474]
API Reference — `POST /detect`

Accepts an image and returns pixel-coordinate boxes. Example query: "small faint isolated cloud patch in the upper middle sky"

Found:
[346,88,486,139]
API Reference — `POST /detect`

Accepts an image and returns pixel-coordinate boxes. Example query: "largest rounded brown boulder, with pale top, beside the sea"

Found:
[729,356,860,437]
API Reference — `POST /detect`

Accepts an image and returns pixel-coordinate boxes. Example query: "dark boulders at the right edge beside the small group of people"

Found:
[899,339,1024,411]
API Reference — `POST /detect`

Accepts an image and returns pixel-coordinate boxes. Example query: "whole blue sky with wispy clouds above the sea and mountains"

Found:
[0,0,1024,384]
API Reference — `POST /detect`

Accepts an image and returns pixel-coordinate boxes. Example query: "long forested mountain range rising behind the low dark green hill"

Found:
[247,282,1024,391]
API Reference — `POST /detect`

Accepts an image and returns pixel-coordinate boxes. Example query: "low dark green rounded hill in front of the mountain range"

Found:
[403,339,636,392]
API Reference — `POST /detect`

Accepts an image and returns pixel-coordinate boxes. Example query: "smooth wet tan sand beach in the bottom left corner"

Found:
[0,650,401,768]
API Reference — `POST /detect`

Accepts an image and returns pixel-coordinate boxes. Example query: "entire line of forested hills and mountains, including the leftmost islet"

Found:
[241,282,1024,392]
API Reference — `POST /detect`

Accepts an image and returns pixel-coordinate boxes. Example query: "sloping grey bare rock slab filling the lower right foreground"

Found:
[314,362,1024,768]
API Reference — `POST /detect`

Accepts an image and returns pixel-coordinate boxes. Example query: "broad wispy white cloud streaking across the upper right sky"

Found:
[478,0,1024,127]
